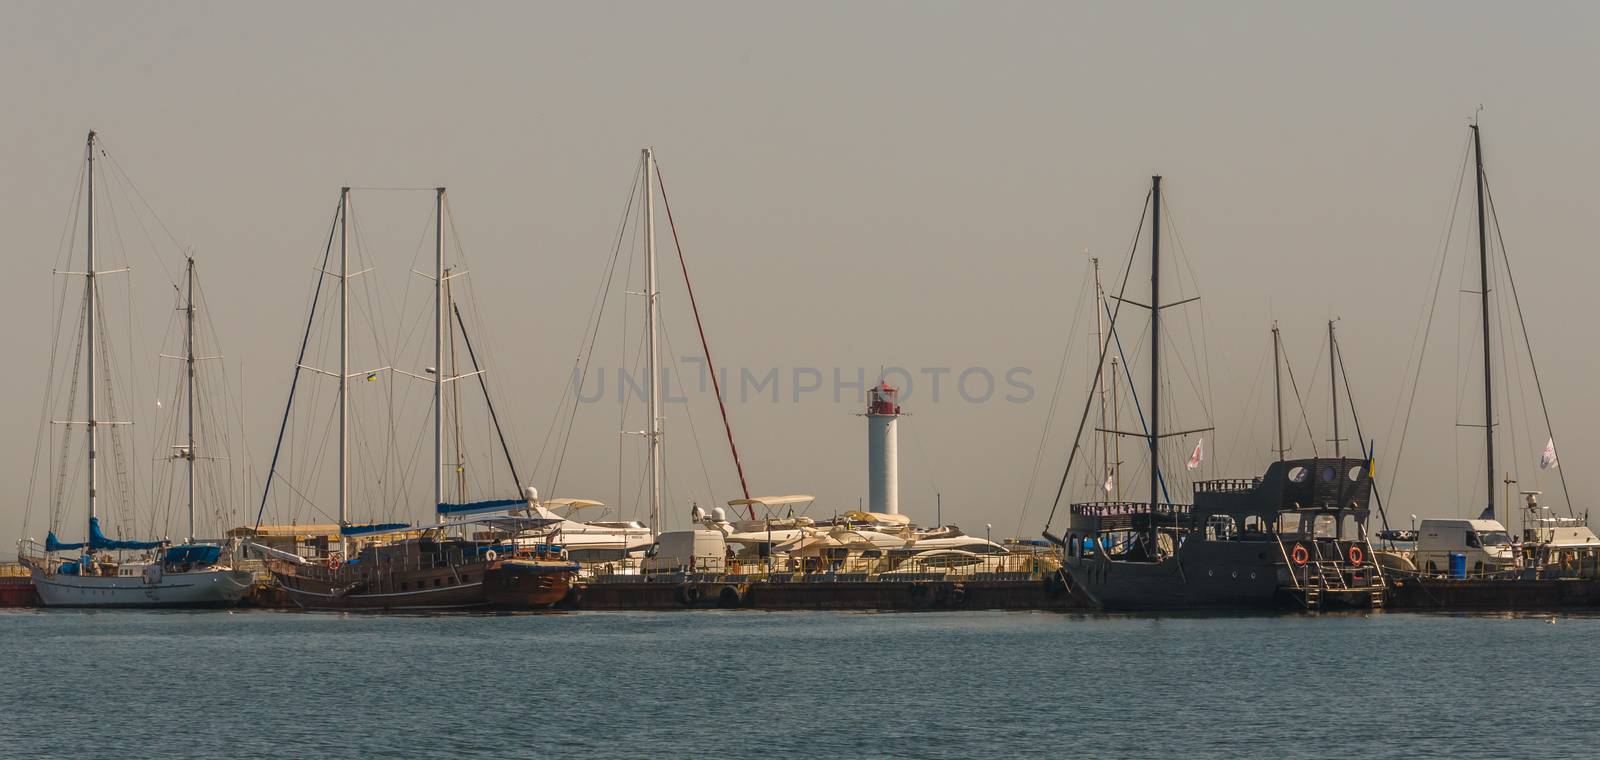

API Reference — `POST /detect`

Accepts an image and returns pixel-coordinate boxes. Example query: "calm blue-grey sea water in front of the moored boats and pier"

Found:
[0,611,1600,760]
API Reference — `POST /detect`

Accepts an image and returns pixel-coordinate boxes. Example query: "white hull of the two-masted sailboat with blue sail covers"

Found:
[32,568,253,608]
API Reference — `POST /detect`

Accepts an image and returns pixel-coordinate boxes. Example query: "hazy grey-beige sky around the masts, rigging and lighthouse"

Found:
[0,2,1600,550]
